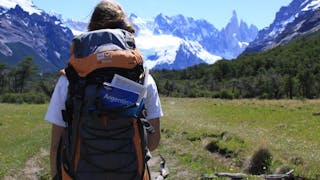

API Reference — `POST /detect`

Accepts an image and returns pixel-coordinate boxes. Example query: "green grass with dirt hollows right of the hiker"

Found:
[160,98,320,179]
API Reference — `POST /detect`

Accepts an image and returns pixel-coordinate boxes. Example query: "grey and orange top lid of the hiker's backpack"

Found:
[68,29,143,77]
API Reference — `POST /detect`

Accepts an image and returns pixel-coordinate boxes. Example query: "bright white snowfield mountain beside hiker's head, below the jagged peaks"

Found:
[130,14,221,69]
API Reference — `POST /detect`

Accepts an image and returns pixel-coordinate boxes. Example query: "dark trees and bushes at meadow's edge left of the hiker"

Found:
[0,56,57,103]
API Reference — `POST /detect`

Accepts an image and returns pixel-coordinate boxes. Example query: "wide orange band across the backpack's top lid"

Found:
[68,49,143,77]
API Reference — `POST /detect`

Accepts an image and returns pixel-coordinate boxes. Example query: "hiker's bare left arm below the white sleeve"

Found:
[50,124,64,178]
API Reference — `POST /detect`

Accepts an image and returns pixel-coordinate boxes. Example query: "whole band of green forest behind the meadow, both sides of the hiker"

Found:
[0,31,320,103]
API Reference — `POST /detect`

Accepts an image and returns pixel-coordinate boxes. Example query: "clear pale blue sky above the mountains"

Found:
[33,0,292,29]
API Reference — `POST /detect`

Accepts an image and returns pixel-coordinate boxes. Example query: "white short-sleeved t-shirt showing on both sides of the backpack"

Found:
[45,75,163,127]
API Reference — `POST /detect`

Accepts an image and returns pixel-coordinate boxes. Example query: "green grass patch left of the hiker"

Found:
[0,104,50,179]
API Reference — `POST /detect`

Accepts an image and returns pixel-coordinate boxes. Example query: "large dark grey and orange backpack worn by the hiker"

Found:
[57,29,150,180]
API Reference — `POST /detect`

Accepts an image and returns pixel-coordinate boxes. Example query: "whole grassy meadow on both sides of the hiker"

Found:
[0,98,320,179]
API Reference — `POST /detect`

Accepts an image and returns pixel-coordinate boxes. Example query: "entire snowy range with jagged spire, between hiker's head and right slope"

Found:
[130,12,258,69]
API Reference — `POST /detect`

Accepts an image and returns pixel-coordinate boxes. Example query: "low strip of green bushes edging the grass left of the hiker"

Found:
[0,92,48,104]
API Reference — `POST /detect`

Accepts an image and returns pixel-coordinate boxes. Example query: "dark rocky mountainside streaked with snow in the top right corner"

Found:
[244,0,320,53]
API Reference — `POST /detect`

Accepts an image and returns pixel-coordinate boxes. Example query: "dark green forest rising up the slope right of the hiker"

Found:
[152,31,320,99]
